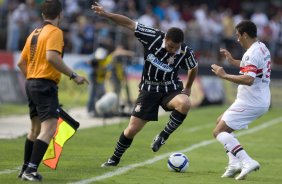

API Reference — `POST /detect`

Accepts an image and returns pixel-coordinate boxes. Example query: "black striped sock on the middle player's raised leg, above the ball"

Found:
[160,110,187,140]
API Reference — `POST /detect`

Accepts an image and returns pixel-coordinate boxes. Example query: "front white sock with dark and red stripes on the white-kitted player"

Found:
[216,132,251,162]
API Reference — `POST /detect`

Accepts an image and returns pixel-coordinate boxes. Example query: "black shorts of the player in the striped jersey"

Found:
[132,90,181,121]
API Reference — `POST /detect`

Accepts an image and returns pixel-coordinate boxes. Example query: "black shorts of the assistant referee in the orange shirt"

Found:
[25,79,59,122]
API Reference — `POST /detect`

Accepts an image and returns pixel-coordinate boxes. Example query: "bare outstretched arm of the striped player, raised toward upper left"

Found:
[91,2,136,31]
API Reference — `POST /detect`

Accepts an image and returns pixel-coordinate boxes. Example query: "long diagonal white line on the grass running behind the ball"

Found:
[70,117,282,184]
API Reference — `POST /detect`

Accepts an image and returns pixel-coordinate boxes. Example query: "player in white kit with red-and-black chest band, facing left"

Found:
[211,20,271,180]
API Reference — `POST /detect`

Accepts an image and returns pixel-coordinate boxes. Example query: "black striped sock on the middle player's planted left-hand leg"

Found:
[111,132,133,162]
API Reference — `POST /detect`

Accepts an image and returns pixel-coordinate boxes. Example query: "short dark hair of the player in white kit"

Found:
[236,20,257,38]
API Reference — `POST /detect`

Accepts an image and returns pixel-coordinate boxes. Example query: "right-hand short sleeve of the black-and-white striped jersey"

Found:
[180,46,198,70]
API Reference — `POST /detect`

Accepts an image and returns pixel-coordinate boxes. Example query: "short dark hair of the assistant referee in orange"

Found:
[40,0,63,20]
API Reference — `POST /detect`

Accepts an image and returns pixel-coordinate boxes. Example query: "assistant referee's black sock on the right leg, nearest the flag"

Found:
[26,139,48,173]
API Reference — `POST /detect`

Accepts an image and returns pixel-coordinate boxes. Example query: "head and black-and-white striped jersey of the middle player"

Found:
[135,23,197,93]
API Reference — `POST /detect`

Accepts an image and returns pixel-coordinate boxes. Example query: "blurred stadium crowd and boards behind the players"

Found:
[0,0,282,112]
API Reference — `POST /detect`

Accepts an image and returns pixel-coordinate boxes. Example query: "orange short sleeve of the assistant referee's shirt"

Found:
[46,29,64,54]
